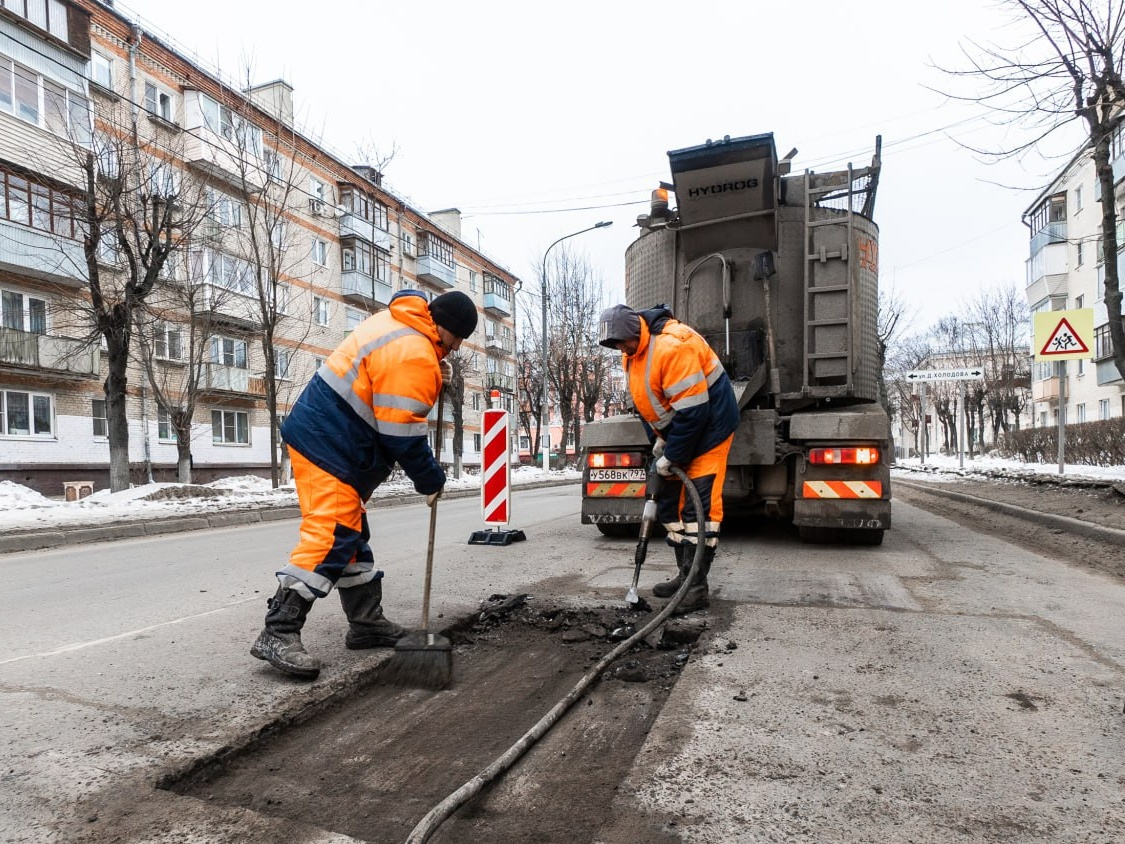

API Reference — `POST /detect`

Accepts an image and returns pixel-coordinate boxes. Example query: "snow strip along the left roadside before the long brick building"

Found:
[0,466,582,532]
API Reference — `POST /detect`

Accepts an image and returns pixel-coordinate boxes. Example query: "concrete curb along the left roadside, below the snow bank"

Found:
[0,478,579,554]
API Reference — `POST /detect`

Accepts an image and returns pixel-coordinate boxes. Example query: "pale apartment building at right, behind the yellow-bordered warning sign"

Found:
[1024,146,1125,425]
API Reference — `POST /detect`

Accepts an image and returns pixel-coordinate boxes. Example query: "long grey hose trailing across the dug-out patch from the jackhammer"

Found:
[406,466,703,844]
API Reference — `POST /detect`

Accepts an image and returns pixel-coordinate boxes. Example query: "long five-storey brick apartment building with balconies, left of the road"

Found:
[0,0,519,495]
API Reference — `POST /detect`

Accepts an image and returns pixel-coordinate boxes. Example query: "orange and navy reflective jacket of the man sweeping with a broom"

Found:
[281,290,446,500]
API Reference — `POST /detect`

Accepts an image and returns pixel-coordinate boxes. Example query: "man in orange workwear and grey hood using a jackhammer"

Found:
[599,305,738,614]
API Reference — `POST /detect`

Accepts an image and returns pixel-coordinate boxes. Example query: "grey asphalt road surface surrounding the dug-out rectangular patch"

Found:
[0,486,1125,844]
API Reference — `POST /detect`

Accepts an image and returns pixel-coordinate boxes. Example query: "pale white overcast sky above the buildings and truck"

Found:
[107,0,1080,337]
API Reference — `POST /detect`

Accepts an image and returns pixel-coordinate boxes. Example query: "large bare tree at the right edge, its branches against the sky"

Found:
[945,0,1125,378]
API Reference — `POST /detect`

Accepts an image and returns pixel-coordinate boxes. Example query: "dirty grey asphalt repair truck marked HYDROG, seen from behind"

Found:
[582,128,892,545]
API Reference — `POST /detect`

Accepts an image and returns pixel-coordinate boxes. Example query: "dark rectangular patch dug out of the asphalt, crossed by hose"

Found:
[163,595,705,844]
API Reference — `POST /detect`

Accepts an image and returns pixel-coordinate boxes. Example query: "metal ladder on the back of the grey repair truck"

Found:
[801,140,880,396]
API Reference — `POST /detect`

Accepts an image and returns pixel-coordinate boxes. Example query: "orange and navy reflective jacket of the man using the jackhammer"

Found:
[623,308,738,466]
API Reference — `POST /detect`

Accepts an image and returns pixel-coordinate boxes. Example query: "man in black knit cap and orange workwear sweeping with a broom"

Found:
[250,290,477,679]
